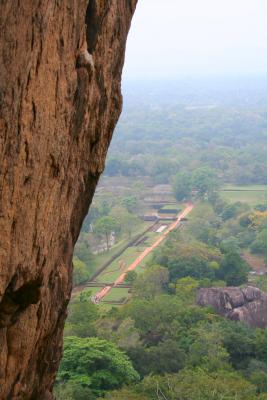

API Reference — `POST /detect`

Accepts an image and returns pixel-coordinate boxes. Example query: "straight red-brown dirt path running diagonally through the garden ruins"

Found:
[94,203,194,302]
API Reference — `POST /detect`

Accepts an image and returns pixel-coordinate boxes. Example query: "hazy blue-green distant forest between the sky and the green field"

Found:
[105,78,267,184]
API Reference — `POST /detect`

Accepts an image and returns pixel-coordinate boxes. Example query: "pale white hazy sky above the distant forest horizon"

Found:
[124,0,267,79]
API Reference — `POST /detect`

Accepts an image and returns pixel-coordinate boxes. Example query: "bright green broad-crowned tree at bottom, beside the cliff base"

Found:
[57,336,139,396]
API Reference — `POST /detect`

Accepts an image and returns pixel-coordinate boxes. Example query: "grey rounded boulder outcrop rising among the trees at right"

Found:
[197,286,267,328]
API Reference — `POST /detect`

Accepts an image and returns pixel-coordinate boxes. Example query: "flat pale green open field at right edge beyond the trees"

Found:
[221,185,267,206]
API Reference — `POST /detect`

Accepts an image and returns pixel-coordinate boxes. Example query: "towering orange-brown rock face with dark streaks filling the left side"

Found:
[0,0,136,400]
